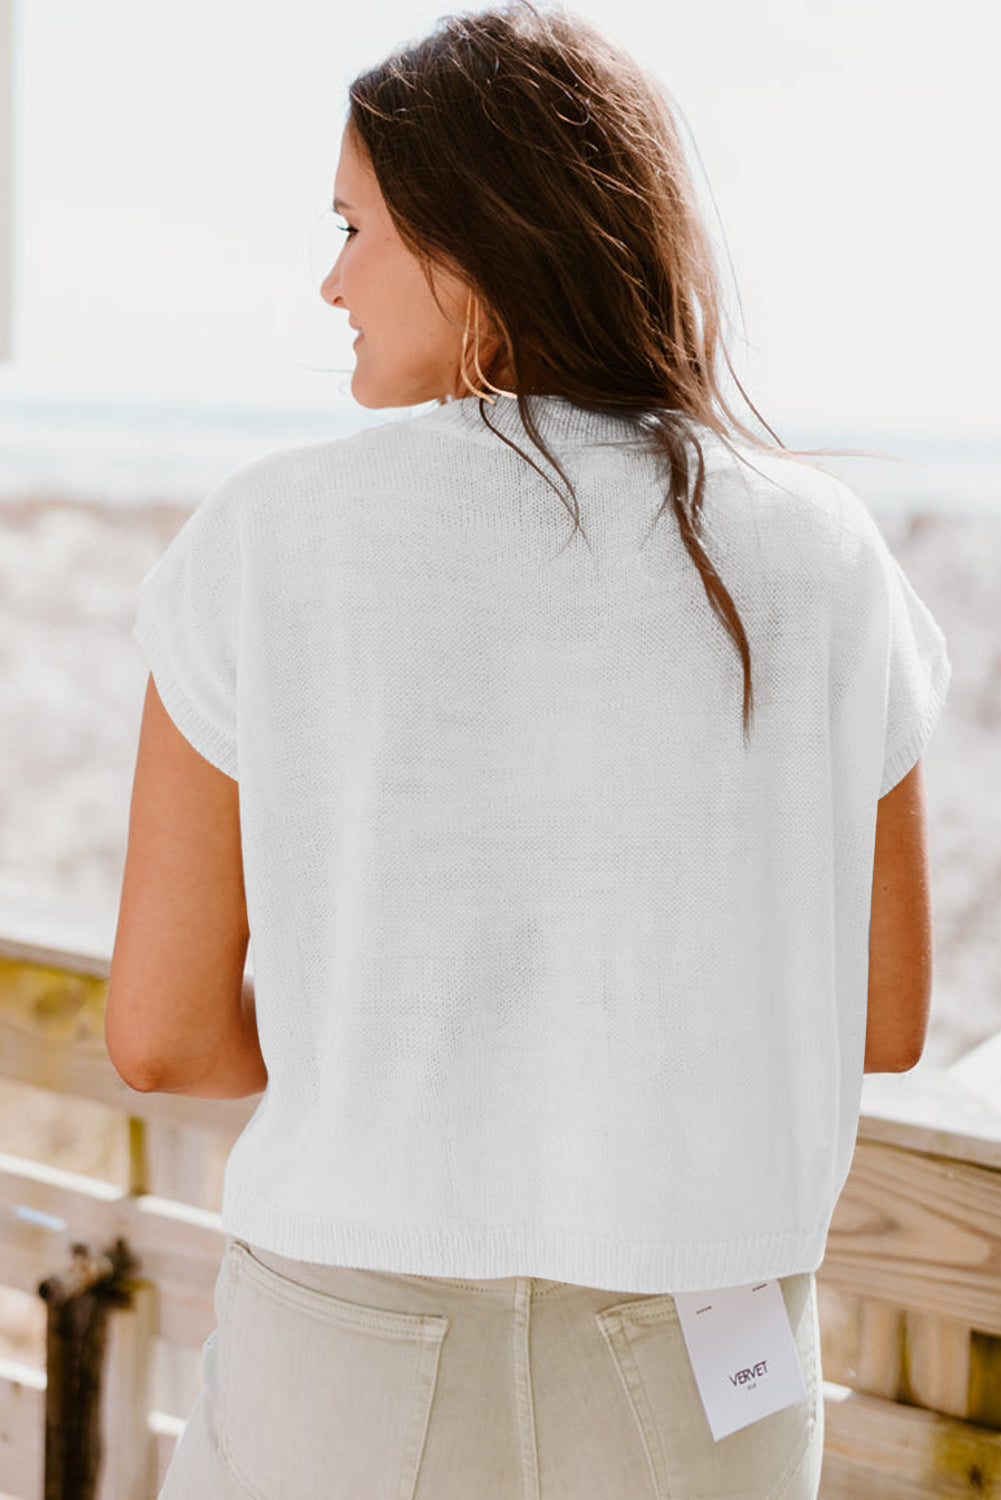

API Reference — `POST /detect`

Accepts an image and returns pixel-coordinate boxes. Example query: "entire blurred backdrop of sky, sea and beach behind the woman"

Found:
[0,0,1001,1181]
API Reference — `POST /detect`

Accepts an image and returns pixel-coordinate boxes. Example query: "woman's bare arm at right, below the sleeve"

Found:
[864,761,932,1073]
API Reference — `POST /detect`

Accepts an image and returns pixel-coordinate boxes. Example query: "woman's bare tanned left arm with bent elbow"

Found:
[105,677,267,1098]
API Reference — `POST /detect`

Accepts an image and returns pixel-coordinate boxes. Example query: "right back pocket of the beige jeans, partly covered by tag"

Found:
[596,1274,824,1500]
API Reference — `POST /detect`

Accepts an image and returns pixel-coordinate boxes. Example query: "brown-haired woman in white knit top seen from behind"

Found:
[107,5,950,1500]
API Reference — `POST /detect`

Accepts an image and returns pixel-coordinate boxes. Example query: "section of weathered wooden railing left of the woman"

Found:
[0,909,257,1500]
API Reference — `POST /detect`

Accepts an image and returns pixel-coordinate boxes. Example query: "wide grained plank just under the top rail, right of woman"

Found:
[818,1140,1001,1334]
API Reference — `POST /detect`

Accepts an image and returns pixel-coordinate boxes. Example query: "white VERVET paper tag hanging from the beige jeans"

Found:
[674,1281,806,1442]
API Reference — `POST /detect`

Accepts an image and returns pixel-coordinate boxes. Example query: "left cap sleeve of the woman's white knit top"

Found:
[132,477,240,780]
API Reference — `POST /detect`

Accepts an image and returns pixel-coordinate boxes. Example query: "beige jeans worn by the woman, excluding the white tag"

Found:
[159,1239,824,1500]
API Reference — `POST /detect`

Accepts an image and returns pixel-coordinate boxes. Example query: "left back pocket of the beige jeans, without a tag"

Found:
[216,1241,449,1500]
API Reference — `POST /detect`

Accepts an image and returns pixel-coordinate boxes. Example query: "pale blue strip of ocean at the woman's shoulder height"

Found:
[0,392,1001,518]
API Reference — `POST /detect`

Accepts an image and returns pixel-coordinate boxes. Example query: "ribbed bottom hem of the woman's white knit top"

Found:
[222,1179,830,1293]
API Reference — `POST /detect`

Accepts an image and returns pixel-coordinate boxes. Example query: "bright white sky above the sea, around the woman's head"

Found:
[5,0,1001,443]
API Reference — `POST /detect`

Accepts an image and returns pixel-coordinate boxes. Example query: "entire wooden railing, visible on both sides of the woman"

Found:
[0,912,1001,1500]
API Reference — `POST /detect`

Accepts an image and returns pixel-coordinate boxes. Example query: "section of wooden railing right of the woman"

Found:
[818,1035,1001,1500]
